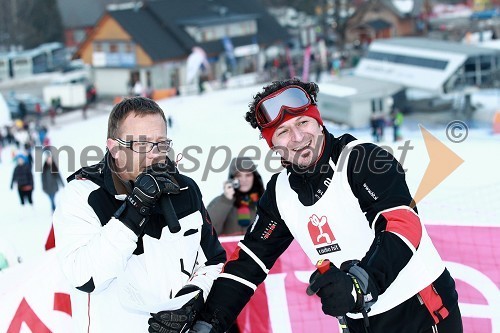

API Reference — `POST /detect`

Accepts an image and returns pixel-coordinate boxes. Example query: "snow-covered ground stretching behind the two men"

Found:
[0,81,500,261]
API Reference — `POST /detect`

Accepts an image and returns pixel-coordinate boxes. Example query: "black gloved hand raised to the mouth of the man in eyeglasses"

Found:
[114,168,179,236]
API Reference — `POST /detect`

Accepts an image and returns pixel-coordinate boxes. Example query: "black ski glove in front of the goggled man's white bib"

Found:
[309,261,378,317]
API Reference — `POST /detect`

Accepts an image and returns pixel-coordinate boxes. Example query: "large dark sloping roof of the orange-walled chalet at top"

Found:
[103,0,289,61]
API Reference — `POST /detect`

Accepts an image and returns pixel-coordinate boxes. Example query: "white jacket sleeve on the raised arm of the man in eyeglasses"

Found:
[53,180,137,293]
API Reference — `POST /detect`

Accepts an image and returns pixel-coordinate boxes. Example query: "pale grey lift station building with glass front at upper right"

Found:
[318,37,500,127]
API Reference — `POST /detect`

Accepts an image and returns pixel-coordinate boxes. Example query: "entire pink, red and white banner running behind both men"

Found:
[0,225,500,333]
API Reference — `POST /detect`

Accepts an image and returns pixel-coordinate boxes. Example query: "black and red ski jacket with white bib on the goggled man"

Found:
[202,129,457,333]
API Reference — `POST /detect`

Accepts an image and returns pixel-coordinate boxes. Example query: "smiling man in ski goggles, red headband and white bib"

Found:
[191,79,463,333]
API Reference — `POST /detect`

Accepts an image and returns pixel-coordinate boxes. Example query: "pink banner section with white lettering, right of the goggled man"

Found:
[427,225,500,333]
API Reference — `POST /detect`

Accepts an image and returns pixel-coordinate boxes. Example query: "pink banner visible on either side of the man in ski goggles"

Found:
[223,226,500,333]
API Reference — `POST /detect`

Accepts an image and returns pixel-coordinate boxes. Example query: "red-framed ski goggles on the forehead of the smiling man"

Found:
[255,85,311,128]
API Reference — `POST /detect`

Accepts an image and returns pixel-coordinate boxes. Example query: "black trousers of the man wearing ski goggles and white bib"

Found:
[346,296,463,333]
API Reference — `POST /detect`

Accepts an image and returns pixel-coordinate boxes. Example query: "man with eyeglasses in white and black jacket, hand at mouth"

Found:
[54,97,226,333]
